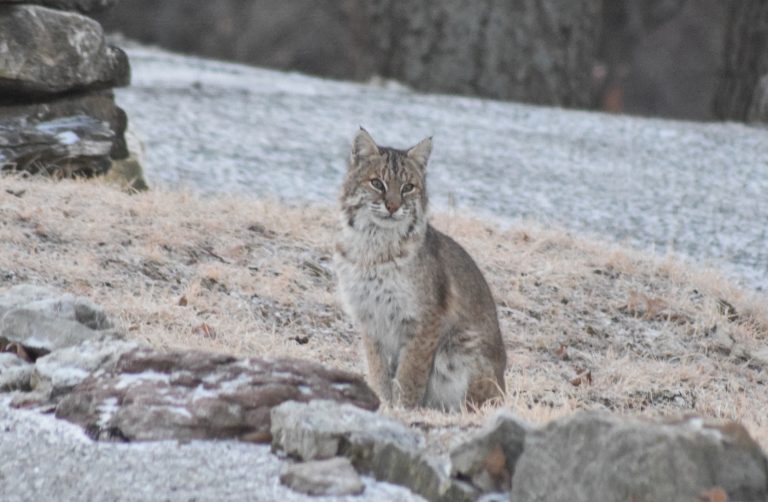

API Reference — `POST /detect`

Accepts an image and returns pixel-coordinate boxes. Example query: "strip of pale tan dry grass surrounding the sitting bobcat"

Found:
[0,177,768,447]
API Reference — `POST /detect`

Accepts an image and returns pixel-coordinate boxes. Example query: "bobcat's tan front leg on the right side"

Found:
[392,326,439,408]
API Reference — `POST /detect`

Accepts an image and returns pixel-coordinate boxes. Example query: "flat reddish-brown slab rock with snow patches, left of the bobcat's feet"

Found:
[56,348,379,441]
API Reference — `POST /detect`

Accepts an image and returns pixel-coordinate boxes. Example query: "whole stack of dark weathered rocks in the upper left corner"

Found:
[0,0,143,186]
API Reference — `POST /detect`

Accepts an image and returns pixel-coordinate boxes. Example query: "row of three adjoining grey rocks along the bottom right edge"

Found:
[272,401,768,502]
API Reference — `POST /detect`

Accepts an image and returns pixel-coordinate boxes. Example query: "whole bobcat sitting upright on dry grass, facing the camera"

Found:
[335,128,507,410]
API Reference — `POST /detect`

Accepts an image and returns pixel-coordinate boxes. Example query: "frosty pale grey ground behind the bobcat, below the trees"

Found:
[117,47,768,289]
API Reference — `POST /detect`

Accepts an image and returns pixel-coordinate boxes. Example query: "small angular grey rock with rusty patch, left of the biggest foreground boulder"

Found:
[451,410,529,493]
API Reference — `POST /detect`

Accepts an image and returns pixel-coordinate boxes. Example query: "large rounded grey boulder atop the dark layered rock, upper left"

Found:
[0,5,130,97]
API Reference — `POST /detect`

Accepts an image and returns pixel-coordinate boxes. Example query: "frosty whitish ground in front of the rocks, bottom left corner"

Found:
[0,398,423,502]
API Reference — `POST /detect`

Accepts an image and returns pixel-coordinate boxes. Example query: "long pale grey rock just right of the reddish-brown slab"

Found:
[272,401,477,500]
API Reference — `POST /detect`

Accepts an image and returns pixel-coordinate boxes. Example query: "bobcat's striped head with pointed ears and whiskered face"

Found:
[341,127,432,234]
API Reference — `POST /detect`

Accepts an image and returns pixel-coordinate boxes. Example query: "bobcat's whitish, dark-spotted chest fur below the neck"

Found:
[338,263,418,355]
